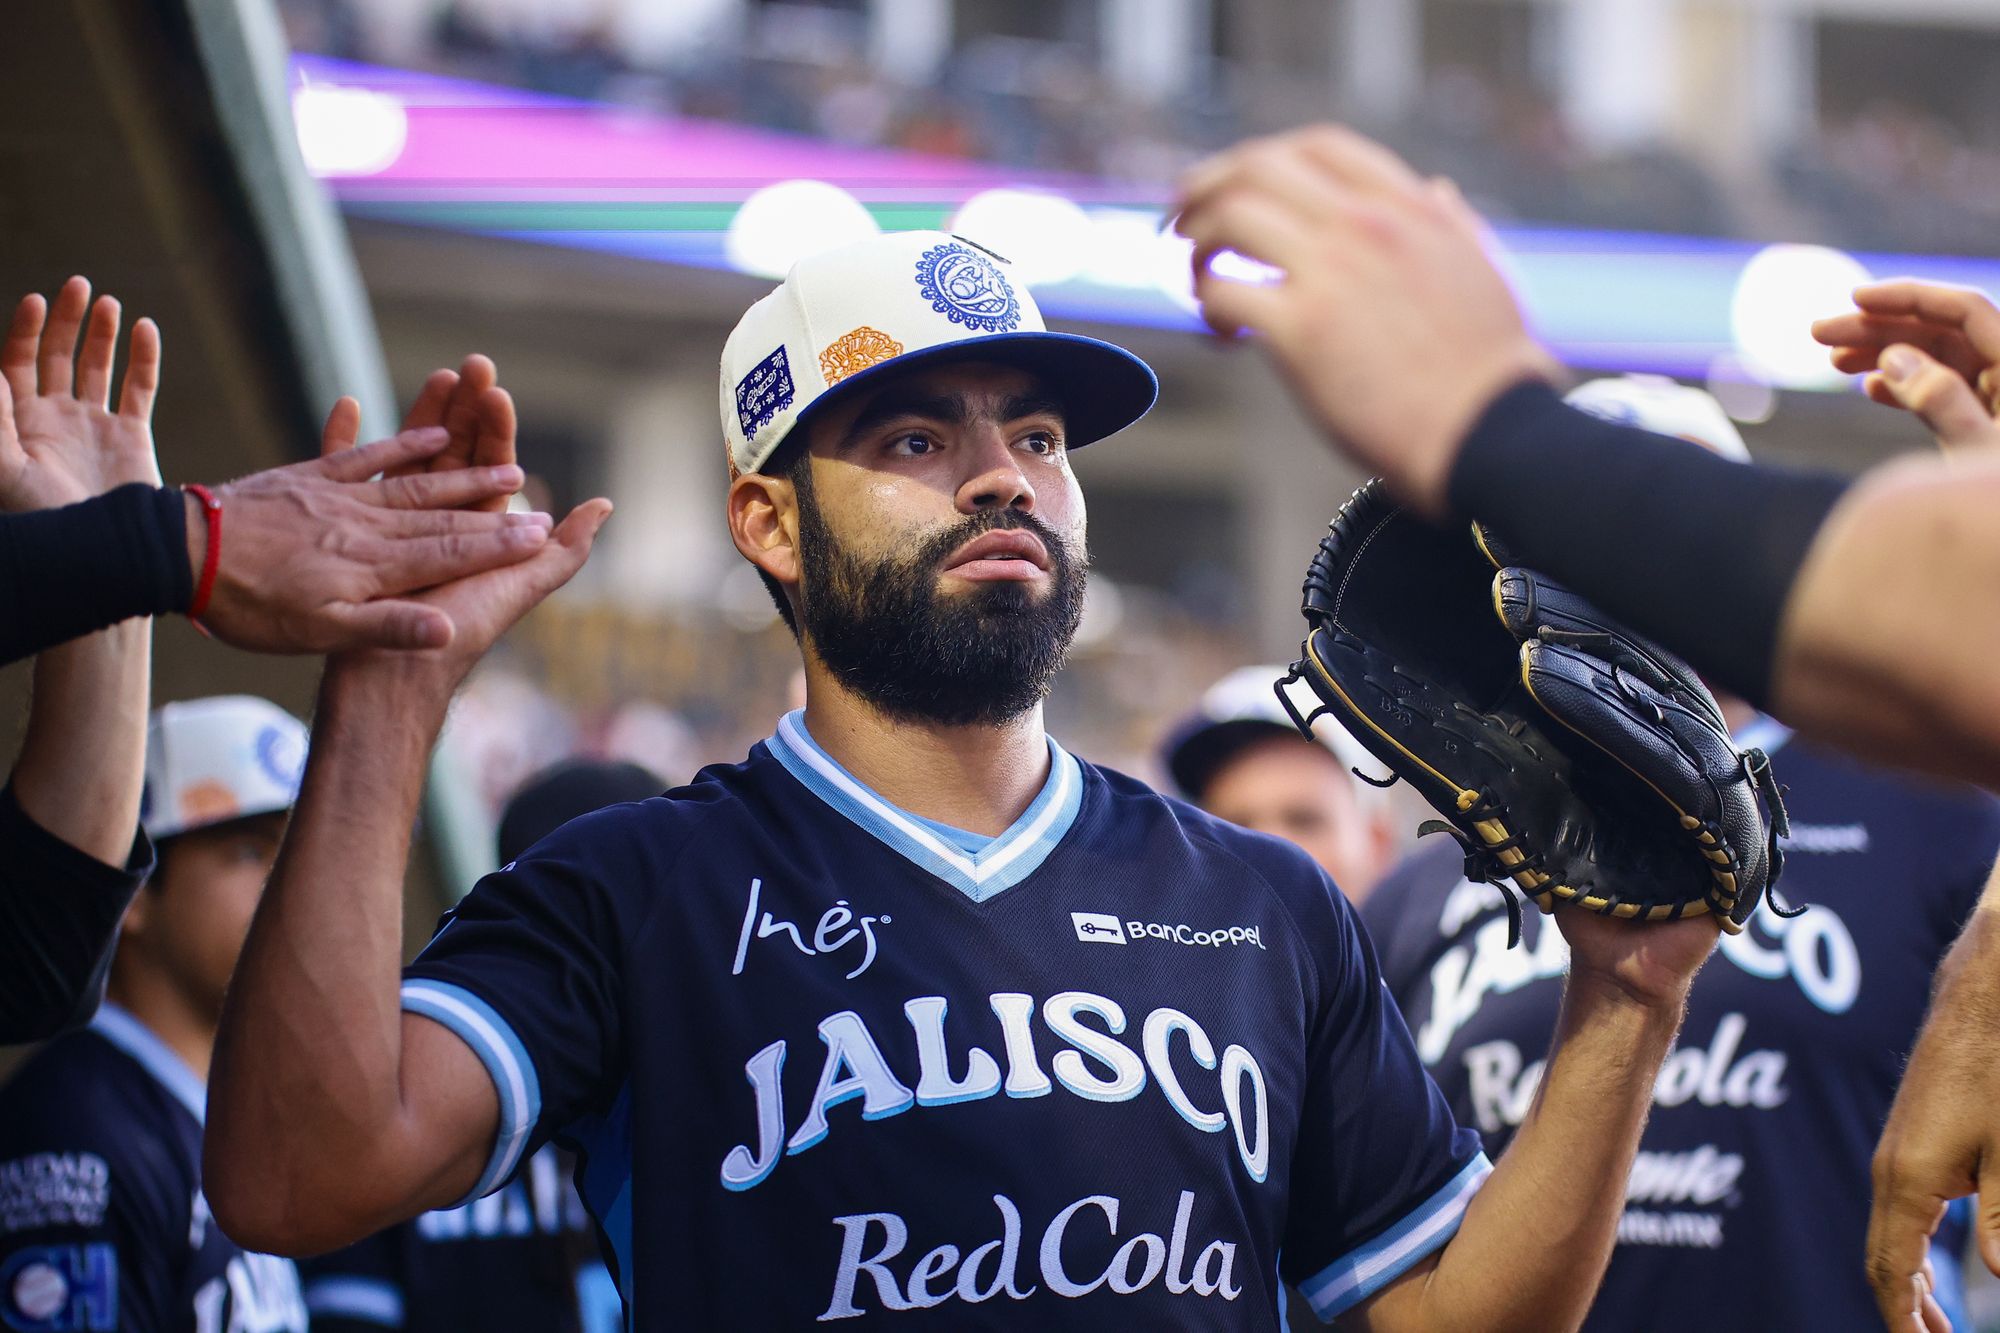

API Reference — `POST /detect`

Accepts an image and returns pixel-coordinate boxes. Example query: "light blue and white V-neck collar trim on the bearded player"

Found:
[766,711,1084,903]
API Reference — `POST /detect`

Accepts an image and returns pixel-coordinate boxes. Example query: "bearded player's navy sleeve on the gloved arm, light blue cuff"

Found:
[1282,872,1492,1321]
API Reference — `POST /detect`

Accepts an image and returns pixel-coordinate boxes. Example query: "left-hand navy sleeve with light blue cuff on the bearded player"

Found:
[402,803,670,1201]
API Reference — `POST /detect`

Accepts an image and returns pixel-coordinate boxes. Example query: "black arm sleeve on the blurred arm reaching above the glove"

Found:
[1448,384,1846,707]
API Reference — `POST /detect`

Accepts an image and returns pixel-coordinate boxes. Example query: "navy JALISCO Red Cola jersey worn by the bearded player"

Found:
[404,715,1488,1329]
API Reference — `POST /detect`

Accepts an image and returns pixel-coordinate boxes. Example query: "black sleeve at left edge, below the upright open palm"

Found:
[0,787,152,1045]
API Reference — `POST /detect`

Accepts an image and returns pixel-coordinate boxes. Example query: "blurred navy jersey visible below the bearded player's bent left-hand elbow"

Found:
[300,1145,624,1333]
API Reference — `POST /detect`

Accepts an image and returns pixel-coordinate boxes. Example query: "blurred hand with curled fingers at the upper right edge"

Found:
[1812,280,2000,454]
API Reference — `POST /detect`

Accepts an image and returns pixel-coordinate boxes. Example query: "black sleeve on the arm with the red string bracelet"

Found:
[0,482,194,664]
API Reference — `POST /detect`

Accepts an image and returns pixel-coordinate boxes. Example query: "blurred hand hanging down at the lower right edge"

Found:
[1868,909,2000,1333]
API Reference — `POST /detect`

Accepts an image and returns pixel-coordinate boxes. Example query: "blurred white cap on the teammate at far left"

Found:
[138,695,306,843]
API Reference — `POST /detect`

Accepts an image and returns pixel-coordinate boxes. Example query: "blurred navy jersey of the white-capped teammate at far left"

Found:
[0,1005,306,1333]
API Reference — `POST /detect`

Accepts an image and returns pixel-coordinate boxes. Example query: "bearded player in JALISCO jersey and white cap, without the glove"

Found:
[208,232,1716,1333]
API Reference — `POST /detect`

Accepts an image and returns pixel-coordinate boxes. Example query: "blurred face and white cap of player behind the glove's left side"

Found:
[1160,667,1396,907]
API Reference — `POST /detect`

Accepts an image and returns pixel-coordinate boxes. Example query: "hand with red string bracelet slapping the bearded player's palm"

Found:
[188,428,550,652]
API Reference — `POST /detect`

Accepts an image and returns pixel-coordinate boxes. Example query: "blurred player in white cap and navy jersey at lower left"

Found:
[0,695,306,1333]
